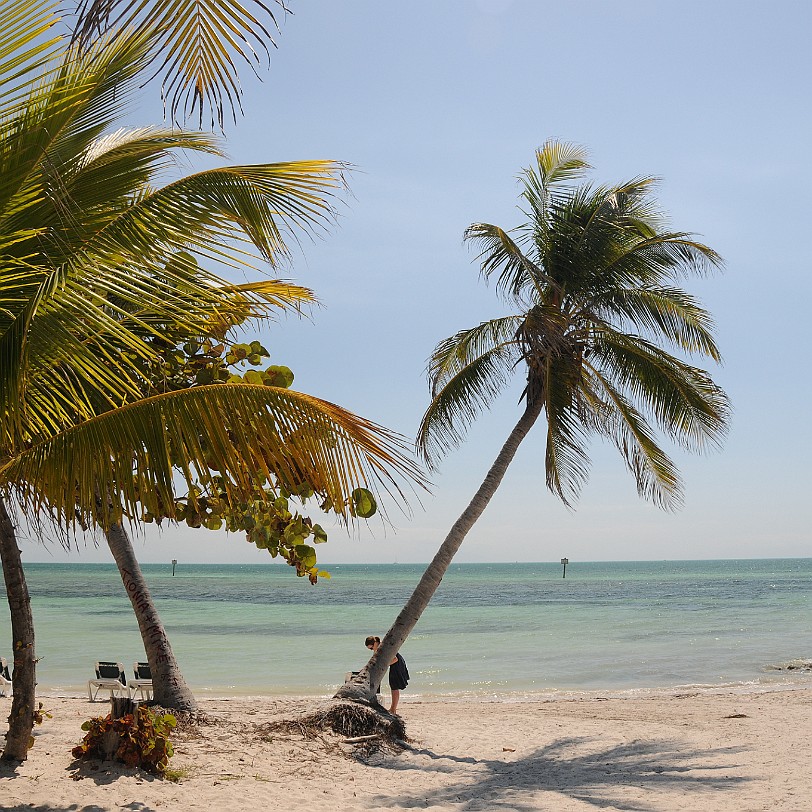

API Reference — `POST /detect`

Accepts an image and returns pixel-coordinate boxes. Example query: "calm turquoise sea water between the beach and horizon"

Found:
[0,559,812,696]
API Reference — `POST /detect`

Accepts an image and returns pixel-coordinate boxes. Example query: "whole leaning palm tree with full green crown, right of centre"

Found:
[339,141,729,700]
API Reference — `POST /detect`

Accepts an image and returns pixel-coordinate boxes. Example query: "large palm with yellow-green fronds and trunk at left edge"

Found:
[0,14,420,760]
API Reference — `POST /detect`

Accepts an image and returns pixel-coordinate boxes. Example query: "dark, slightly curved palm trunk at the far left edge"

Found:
[0,499,37,761]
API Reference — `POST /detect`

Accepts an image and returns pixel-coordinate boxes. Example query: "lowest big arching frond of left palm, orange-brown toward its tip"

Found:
[0,384,425,527]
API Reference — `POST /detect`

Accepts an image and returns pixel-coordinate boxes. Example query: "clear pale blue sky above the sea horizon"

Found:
[22,0,812,563]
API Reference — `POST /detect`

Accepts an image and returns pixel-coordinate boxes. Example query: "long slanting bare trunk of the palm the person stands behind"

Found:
[335,398,544,702]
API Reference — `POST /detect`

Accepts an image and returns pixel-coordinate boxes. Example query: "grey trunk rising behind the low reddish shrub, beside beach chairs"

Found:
[105,524,197,711]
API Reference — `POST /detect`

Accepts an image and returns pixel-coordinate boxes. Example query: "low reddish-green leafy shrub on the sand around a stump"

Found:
[71,705,177,775]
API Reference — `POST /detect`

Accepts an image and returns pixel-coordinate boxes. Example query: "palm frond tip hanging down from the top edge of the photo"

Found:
[75,0,289,127]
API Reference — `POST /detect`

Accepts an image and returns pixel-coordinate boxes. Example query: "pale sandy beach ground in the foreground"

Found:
[0,690,812,812]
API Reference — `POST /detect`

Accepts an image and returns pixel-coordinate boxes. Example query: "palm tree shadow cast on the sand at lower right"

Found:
[382,737,751,812]
